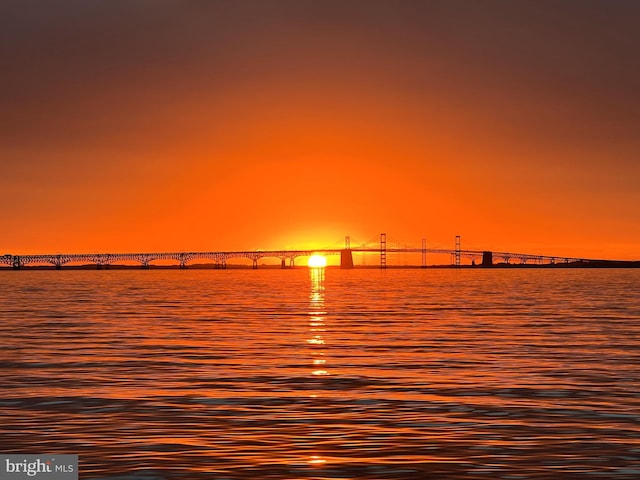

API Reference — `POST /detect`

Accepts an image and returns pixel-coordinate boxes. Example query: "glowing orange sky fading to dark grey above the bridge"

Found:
[0,0,640,259]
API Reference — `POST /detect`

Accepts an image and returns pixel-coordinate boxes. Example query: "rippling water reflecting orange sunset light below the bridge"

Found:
[0,269,640,480]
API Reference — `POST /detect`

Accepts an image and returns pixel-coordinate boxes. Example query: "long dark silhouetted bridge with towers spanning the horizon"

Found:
[0,233,597,270]
